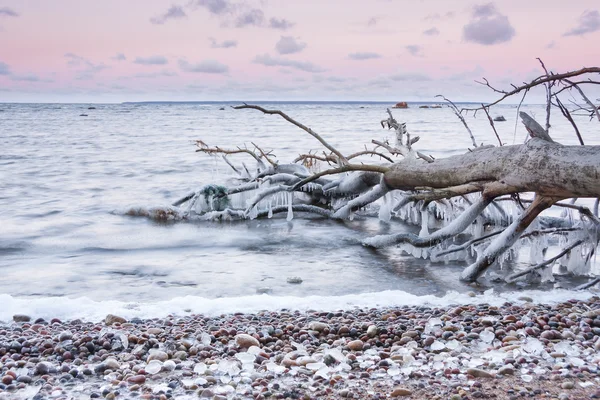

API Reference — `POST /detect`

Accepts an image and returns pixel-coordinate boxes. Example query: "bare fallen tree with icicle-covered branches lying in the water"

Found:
[130,61,600,283]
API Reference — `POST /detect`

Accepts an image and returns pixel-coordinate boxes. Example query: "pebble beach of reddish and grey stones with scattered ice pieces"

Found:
[0,297,600,400]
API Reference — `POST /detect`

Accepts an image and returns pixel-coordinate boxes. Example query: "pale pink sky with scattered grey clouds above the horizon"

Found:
[0,0,600,102]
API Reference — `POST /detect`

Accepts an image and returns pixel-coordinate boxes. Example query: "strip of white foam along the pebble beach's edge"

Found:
[0,289,593,322]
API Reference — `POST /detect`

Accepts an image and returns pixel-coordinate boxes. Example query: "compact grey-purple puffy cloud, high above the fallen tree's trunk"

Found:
[463,3,515,46]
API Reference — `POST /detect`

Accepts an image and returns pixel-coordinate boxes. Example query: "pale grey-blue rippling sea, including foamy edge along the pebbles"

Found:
[0,101,600,321]
